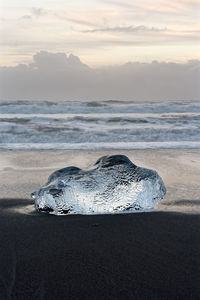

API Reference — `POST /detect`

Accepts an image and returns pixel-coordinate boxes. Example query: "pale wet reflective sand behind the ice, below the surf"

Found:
[0,149,200,213]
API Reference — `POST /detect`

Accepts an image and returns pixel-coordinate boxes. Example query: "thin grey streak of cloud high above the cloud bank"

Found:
[83,25,167,33]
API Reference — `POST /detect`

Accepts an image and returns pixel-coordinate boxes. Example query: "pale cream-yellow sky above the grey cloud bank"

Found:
[0,0,200,67]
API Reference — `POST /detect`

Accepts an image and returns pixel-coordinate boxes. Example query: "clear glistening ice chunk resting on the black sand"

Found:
[31,155,166,215]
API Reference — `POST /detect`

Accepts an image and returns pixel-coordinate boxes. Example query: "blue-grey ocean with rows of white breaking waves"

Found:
[0,101,200,150]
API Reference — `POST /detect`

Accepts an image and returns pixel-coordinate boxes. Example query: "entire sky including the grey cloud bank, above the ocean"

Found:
[0,0,200,101]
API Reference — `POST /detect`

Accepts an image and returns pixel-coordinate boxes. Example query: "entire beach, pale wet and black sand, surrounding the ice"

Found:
[0,150,200,299]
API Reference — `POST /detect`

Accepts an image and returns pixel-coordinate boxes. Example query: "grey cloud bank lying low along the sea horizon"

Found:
[0,51,200,101]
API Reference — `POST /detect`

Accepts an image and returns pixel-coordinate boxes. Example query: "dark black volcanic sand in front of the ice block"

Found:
[0,199,200,300]
